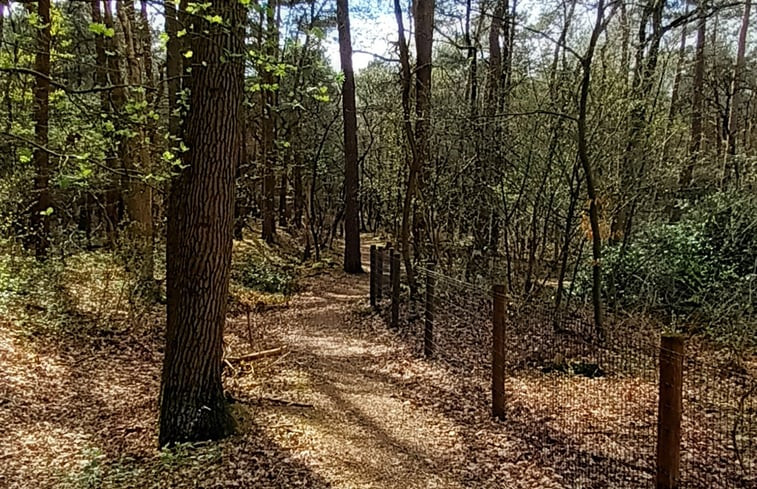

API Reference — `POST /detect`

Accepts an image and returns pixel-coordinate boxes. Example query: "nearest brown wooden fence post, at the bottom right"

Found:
[657,335,684,489]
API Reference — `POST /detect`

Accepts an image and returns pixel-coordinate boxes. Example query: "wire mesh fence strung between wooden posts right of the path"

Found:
[368,248,757,489]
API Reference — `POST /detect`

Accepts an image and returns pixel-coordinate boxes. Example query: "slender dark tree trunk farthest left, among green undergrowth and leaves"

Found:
[31,0,52,260]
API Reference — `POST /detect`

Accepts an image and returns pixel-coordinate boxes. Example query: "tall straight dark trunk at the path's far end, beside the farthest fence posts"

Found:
[336,0,363,273]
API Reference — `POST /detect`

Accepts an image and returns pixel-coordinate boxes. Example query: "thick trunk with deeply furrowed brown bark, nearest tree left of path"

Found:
[159,0,244,446]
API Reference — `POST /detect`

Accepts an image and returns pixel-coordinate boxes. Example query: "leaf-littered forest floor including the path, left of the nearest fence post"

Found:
[0,241,752,489]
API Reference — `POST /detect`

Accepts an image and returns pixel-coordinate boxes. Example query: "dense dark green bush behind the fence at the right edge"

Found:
[575,192,757,345]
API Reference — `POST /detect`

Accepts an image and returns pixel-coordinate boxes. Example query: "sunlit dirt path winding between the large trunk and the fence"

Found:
[224,242,463,488]
